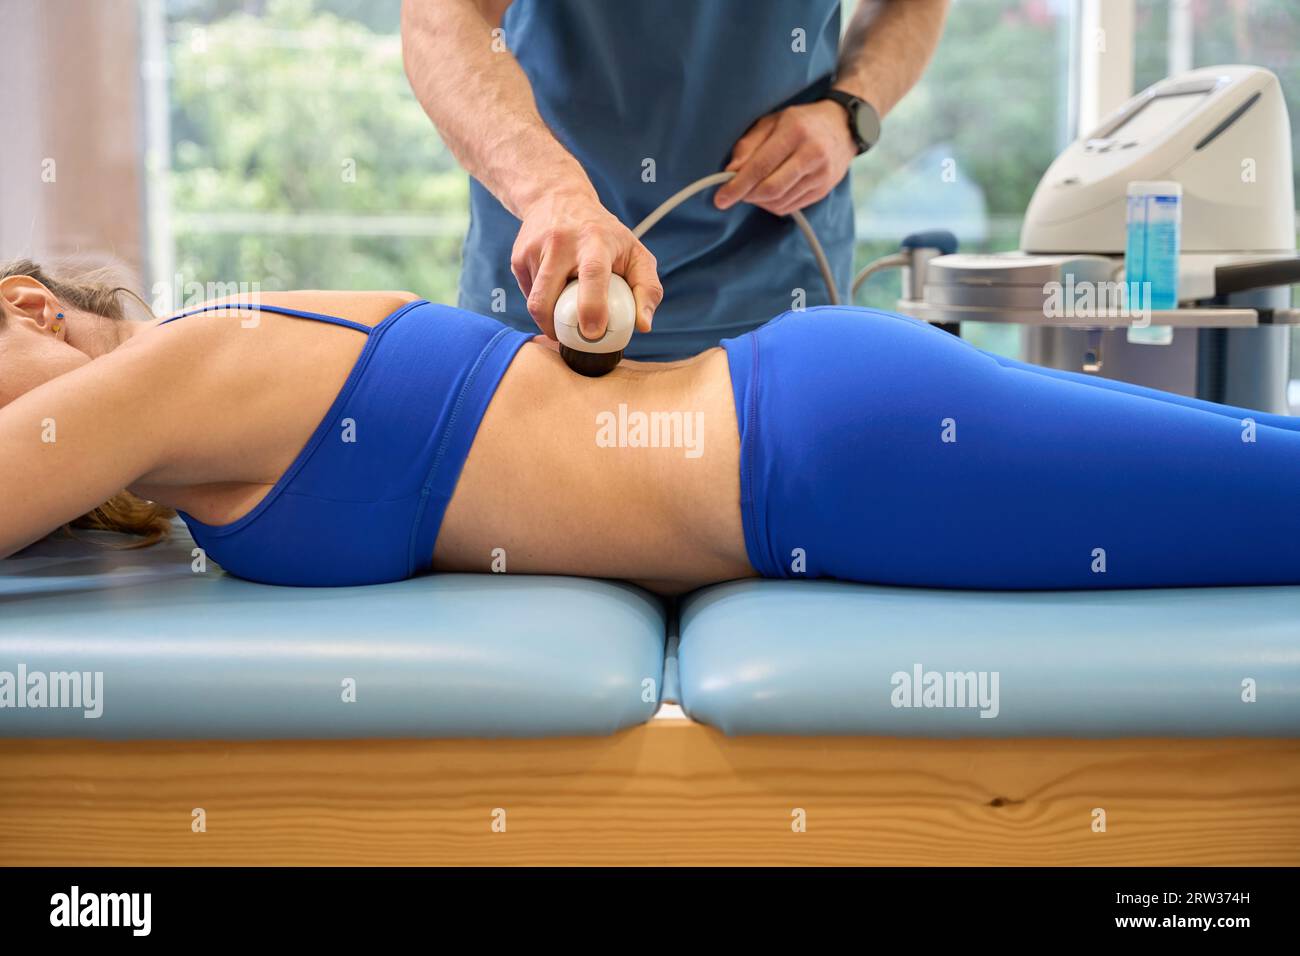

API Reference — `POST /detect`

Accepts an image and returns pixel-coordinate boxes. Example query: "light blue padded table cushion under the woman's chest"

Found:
[0,527,666,739]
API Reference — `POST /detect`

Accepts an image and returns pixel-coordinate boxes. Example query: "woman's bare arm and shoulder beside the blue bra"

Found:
[0,291,415,558]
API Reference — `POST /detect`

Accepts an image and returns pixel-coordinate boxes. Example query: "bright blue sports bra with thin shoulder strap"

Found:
[160,299,532,587]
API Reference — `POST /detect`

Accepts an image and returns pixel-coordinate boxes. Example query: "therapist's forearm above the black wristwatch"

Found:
[835,0,949,116]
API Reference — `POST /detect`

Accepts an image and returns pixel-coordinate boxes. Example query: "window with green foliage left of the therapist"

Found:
[142,0,468,302]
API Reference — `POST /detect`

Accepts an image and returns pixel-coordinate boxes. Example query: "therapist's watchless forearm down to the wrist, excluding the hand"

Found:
[402,0,595,219]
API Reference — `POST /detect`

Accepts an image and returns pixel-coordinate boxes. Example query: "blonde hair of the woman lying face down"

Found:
[0,259,176,548]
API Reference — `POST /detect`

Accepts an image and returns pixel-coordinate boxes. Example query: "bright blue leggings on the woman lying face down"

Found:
[723,306,1300,589]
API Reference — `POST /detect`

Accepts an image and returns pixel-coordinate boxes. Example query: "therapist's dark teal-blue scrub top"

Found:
[460,0,853,359]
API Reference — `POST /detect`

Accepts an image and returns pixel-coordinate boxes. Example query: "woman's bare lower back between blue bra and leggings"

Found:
[434,339,754,593]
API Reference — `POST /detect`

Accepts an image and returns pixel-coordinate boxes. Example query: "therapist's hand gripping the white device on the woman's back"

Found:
[510,190,663,338]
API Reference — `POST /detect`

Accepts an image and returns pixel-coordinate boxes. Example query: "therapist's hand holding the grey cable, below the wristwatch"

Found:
[714,100,858,216]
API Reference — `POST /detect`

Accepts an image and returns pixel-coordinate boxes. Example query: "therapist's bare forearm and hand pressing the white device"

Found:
[402,0,663,338]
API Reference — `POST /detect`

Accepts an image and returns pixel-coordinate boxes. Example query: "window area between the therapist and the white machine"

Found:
[850,0,1075,355]
